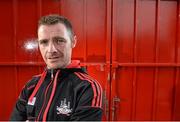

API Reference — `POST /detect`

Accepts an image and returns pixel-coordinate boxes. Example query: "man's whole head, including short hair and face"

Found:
[38,15,76,69]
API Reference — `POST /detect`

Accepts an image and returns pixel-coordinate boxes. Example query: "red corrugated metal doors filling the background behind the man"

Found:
[0,0,180,120]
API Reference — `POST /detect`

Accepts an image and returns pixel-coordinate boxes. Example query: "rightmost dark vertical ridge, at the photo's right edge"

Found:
[171,0,180,120]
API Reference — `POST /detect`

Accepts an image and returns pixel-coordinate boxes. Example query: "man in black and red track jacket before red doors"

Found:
[10,15,102,121]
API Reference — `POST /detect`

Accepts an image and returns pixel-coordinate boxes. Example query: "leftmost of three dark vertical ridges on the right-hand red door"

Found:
[131,0,138,120]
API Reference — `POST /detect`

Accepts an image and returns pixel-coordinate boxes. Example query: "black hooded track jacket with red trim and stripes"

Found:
[10,61,102,121]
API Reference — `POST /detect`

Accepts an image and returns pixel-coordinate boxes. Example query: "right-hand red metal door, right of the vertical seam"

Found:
[111,0,179,120]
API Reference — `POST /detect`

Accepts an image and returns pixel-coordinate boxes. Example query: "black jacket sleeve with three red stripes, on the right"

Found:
[70,80,102,121]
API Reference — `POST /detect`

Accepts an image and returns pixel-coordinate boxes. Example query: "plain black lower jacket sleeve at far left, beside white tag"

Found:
[10,87,27,121]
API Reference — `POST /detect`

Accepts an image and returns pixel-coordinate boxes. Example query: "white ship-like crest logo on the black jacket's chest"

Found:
[56,98,72,116]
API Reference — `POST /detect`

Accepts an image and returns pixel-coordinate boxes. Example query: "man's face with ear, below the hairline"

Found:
[38,23,76,69]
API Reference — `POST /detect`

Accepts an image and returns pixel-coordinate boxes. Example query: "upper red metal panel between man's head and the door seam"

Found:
[61,0,108,63]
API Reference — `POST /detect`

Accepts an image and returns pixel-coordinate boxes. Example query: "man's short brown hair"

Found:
[38,14,74,40]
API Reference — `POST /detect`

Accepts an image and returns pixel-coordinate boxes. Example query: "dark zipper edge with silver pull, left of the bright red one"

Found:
[36,69,54,121]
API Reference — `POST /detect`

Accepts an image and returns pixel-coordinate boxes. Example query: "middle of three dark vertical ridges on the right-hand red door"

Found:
[152,0,160,120]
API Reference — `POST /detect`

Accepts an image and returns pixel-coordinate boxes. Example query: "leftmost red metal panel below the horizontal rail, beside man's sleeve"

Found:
[0,66,17,120]
